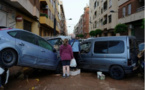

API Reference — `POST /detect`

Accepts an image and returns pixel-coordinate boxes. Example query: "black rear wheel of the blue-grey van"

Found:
[110,66,125,80]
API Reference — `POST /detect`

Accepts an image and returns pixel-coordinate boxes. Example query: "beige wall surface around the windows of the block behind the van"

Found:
[89,0,118,31]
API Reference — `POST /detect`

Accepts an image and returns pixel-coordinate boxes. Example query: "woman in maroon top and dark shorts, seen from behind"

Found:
[60,39,73,78]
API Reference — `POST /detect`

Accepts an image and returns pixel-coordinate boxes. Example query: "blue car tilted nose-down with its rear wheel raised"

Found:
[0,28,60,70]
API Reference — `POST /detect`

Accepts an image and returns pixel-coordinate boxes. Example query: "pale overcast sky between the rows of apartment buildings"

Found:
[62,0,89,34]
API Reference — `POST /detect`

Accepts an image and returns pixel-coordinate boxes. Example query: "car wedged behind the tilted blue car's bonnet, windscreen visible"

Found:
[43,36,71,51]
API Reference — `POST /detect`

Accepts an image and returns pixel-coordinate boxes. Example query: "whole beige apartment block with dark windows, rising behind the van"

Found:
[89,0,118,36]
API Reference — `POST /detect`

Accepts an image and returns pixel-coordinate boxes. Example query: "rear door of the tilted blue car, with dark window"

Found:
[16,31,40,67]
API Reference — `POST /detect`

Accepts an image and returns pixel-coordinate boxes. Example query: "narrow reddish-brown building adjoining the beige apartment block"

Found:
[83,5,90,38]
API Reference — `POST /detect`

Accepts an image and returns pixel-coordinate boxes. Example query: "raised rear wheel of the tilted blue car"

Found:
[0,49,17,68]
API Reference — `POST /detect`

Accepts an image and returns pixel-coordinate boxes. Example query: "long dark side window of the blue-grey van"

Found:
[94,41,124,54]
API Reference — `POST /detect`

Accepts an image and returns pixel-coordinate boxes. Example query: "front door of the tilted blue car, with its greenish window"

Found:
[37,37,57,69]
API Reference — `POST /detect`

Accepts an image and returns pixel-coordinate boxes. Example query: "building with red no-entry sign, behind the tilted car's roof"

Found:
[0,0,40,35]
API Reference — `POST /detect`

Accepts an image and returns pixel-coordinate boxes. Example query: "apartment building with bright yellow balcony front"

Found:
[39,0,60,36]
